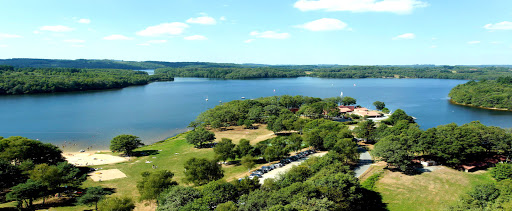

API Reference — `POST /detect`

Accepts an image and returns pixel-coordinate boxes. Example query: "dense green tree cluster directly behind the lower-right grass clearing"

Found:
[356,109,512,171]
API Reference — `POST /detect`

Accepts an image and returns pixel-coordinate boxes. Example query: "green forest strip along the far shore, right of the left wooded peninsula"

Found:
[156,65,512,80]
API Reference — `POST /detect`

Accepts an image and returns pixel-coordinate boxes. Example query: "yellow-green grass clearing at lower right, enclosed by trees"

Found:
[376,167,494,211]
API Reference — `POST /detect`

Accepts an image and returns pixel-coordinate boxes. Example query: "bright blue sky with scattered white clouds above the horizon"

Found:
[0,0,512,65]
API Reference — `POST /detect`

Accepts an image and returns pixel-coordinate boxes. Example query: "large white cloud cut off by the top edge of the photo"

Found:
[294,0,428,14]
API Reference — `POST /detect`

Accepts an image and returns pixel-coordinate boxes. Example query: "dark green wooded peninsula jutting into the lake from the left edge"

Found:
[0,66,174,95]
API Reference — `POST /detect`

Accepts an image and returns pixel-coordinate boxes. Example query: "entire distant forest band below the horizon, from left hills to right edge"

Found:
[0,58,512,80]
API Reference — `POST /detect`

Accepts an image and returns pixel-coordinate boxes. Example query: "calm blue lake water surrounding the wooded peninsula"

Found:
[0,77,512,150]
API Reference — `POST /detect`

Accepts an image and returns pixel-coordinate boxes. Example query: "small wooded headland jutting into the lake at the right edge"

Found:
[448,76,512,110]
